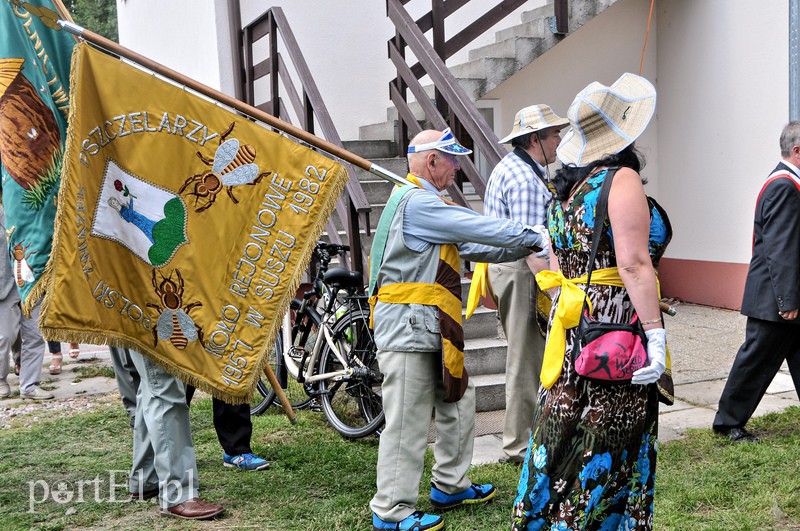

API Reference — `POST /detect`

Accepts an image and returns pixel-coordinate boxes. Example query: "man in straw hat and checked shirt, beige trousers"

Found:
[484,105,568,464]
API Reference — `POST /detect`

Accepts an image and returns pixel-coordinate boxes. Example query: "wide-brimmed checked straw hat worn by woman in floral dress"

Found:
[556,73,656,166]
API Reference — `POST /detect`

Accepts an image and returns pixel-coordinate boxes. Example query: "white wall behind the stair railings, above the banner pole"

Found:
[117,0,545,140]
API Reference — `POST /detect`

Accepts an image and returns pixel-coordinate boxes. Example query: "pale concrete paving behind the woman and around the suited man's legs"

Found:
[473,304,800,464]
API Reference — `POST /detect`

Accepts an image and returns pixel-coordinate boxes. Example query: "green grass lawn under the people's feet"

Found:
[0,397,800,531]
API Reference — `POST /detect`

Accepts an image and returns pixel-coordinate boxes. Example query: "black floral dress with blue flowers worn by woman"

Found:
[513,171,671,531]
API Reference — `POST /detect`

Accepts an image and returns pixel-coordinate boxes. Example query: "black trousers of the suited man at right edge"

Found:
[714,317,800,431]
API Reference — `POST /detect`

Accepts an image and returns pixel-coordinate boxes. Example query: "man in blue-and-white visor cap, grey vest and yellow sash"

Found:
[369,130,546,531]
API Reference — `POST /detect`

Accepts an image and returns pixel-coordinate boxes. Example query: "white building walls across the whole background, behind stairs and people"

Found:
[117,0,789,307]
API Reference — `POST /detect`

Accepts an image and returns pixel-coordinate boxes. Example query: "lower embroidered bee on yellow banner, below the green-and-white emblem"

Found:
[147,269,203,350]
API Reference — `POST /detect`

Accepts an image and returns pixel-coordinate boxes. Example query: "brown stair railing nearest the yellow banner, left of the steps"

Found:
[240,7,371,273]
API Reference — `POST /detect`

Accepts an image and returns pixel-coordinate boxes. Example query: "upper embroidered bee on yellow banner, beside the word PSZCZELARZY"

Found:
[178,123,272,212]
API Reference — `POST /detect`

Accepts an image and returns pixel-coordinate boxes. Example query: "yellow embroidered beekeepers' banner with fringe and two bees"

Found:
[40,44,347,402]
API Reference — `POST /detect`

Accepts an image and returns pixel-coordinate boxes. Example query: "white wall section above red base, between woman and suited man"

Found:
[656,0,789,263]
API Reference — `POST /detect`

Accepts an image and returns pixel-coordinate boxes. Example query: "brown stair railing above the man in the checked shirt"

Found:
[386,0,567,206]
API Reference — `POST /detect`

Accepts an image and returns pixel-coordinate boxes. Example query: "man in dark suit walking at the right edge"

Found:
[713,121,800,442]
